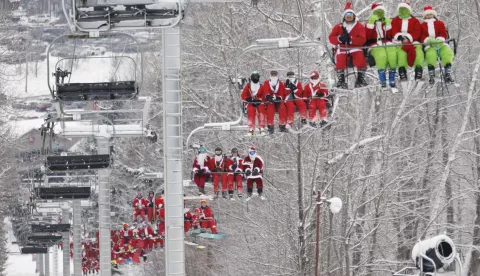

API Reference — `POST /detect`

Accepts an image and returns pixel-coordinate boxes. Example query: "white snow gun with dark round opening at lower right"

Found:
[412,235,456,272]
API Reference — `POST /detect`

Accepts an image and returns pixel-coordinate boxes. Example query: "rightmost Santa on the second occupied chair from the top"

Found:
[303,71,328,127]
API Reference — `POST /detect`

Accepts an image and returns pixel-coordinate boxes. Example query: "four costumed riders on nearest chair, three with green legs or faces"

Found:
[329,2,454,89]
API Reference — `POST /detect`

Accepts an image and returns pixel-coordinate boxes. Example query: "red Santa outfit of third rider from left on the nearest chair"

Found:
[392,3,421,67]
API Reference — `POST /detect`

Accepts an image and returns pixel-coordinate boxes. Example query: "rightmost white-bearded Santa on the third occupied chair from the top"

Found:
[243,147,266,200]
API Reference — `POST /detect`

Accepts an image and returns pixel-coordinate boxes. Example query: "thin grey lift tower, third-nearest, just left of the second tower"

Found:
[73,199,82,276]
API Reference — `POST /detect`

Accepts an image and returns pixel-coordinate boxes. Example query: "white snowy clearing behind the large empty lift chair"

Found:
[0,53,140,98]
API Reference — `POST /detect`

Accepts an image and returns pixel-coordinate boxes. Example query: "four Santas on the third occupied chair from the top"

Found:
[193,146,266,200]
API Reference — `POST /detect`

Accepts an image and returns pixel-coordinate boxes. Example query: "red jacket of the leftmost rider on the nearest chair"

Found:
[328,21,367,53]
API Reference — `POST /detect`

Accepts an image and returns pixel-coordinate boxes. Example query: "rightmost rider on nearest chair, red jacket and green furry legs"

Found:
[421,6,454,84]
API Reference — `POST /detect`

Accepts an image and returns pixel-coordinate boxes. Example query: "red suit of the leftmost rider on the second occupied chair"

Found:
[242,82,266,131]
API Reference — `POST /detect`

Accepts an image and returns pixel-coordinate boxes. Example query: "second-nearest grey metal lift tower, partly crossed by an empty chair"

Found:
[97,137,112,276]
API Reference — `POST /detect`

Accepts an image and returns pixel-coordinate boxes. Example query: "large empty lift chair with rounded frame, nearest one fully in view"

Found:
[47,32,143,102]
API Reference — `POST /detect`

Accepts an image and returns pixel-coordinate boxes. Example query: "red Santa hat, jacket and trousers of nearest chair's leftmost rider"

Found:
[328,2,367,70]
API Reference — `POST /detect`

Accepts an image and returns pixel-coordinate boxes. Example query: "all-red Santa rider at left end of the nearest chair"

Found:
[329,2,368,89]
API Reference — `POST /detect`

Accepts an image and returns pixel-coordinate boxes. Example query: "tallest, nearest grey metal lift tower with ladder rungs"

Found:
[162,27,185,276]
